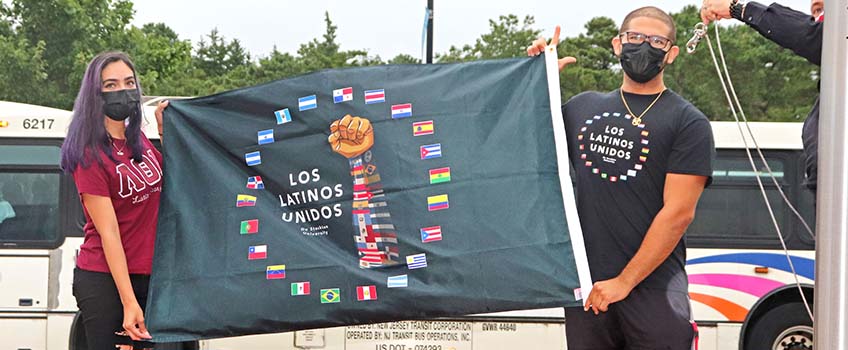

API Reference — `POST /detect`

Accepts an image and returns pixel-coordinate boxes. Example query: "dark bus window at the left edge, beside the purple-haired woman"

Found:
[0,145,62,247]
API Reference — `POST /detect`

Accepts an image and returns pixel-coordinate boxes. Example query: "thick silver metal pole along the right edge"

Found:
[813,0,848,350]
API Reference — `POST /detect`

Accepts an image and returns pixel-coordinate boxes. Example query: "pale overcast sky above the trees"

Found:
[133,0,810,60]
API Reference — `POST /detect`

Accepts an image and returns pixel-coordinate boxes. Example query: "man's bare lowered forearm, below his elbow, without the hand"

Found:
[618,207,695,287]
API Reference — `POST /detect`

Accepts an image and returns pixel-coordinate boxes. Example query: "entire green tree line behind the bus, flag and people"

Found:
[0,0,819,121]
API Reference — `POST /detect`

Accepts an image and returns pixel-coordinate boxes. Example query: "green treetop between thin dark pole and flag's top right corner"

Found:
[436,15,541,63]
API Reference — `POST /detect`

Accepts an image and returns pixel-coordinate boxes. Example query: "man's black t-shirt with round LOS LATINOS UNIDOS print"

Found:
[563,90,715,292]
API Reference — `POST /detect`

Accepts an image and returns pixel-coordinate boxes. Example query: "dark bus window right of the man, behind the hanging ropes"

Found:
[687,151,797,248]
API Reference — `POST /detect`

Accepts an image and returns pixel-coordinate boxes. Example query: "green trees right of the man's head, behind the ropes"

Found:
[666,6,818,121]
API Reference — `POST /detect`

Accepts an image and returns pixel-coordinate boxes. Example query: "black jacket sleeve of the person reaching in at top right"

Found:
[742,1,824,66]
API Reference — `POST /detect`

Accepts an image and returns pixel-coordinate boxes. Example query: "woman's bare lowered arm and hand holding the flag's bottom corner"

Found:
[82,193,151,340]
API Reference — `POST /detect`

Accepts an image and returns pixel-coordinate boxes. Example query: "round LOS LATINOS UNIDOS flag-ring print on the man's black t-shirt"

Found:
[577,112,650,182]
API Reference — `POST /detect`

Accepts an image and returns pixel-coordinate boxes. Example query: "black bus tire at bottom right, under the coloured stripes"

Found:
[745,302,813,350]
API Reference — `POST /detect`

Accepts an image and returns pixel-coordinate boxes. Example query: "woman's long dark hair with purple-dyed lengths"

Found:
[62,51,142,173]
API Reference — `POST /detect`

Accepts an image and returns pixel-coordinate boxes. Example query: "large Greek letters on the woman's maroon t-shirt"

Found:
[115,149,162,200]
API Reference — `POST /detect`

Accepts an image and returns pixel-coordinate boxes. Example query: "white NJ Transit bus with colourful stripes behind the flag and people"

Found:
[0,99,814,350]
